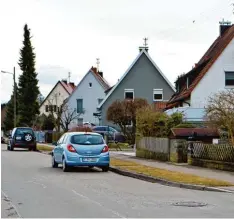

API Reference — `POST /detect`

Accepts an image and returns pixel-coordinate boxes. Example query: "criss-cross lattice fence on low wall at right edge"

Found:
[191,142,234,162]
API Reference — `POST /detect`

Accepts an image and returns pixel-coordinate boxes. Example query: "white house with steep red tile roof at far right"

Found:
[166,22,234,109]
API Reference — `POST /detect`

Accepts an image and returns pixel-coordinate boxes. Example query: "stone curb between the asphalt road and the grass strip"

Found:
[109,167,234,194]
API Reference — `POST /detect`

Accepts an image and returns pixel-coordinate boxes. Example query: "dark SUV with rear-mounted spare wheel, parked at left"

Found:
[7,127,37,151]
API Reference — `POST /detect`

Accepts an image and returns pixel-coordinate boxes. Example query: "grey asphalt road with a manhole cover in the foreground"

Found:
[1,145,234,218]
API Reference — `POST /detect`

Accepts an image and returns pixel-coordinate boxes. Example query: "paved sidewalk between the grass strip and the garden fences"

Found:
[111,152,234,186]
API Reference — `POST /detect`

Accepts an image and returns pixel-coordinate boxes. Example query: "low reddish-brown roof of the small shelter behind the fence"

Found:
[171,128,219,137]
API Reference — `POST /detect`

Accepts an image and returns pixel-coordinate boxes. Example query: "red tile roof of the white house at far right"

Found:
[167,25,234,109]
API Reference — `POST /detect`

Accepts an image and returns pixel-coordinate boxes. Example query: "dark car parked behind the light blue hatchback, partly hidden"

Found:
[92,126,125,142]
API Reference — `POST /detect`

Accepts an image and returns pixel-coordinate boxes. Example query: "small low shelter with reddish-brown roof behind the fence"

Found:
[169,128,220,144]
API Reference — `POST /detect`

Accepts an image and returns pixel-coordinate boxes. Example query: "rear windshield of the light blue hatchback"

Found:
[71,134,104,145]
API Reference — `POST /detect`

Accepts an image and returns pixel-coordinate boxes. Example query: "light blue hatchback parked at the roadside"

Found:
[52,132,110,172]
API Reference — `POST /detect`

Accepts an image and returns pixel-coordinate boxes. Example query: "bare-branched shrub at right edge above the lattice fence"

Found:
[206,89,234,146]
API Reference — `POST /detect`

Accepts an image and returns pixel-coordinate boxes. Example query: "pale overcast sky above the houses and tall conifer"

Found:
[0,0,234,102]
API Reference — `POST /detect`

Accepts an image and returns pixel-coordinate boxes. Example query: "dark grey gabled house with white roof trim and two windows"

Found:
[98,47,175,125]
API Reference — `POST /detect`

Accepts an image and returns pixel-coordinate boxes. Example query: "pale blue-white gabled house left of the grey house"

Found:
[67,67,110,128]
